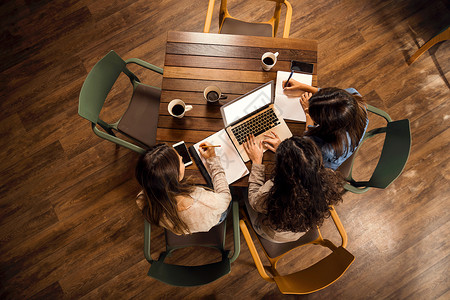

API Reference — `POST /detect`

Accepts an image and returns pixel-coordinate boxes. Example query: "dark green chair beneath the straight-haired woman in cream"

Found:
[144,201,241,287]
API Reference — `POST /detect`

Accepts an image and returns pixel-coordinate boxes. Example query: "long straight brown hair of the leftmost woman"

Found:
[136,144,193,234]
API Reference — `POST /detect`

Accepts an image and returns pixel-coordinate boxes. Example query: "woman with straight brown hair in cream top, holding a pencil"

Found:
[136,143,231,234]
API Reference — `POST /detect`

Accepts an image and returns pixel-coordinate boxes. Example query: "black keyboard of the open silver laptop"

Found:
[231,109,280,145]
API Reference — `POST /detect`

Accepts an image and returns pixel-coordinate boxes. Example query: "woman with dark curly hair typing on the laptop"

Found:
[244,136,342,243]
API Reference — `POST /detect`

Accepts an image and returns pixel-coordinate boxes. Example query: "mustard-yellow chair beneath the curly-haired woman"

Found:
[239,206,355,294]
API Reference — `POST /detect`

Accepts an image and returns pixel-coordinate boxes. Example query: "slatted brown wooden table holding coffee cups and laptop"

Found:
[157,31,317,186]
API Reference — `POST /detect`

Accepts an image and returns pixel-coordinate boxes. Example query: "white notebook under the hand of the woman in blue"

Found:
[275,71,312,122]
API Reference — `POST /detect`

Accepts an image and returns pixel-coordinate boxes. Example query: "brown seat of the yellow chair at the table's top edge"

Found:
[220,18,273,37]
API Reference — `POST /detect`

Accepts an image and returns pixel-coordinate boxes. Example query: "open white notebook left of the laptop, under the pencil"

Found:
[189,129,249,184]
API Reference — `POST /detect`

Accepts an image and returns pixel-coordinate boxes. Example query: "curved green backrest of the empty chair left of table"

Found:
[78,50,131,124]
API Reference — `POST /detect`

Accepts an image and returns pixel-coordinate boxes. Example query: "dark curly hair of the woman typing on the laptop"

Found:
[268,136,343,232]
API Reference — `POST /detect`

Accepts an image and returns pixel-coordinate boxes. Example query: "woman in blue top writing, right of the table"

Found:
[273,79,369,170]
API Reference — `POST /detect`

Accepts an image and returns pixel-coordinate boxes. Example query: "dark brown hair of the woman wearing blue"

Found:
[306,87,367,157]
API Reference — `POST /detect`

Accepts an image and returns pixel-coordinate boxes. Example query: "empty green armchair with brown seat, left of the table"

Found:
[78,50,163,153]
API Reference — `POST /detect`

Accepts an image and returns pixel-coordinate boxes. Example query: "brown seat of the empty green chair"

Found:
[117,84,161,147]
